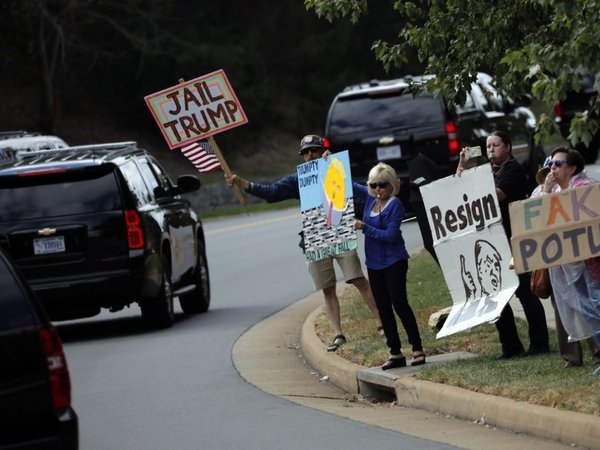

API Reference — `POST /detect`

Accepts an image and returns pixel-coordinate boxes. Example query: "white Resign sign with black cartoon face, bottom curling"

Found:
[420,164,519,338]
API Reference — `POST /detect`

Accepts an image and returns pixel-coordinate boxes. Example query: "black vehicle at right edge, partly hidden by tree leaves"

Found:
[554,73,600,164]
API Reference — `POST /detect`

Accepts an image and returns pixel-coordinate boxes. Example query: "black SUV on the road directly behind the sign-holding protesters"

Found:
[325,73,544,206]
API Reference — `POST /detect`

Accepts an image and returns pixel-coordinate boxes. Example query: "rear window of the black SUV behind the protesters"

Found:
[328,90,443,136]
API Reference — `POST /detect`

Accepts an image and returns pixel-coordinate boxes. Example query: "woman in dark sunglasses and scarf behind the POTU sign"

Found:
[532,147,600,375]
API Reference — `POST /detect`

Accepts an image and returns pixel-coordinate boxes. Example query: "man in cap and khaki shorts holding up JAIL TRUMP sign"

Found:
[225,134,383,352]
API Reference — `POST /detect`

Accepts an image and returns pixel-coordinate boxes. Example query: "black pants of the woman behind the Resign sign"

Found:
[496,273,550,355]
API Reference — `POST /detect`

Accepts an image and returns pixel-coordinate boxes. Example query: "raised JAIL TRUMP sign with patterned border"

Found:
[144,70,248,149]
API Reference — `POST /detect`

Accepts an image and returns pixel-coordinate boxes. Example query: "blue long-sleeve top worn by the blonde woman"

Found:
[352,183,408,270]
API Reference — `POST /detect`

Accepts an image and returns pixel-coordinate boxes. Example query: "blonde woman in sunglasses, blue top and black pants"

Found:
[353,163,425,370]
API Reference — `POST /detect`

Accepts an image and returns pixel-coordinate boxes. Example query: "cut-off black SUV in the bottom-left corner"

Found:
[0,250,79,450]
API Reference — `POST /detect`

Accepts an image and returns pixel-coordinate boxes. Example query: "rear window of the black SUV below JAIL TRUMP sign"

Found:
[0,169,122,222]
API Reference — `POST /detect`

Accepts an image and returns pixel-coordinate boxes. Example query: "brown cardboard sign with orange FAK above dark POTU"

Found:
[509,184,600,273]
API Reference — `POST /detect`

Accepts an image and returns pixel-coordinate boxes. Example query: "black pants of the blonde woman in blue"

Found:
[367,259,423,355]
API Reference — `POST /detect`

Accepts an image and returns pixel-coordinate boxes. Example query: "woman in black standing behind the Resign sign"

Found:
[456,131,550,359]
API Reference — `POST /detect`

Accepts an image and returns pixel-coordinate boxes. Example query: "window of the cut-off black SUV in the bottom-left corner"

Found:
[0,258,35,330]
